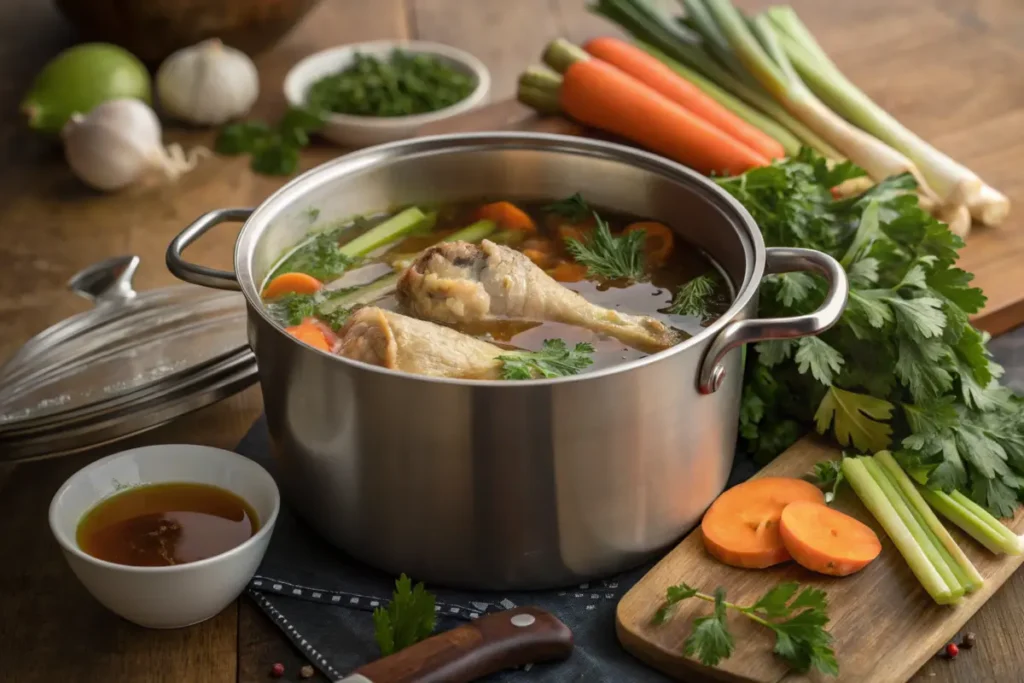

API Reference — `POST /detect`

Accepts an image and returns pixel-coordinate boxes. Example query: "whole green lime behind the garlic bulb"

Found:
[22,43,152,133]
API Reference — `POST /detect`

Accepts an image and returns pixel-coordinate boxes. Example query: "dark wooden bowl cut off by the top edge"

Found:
[55,0,319,65]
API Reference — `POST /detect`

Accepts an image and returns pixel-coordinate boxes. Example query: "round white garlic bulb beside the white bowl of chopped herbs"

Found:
[157,38,259,126]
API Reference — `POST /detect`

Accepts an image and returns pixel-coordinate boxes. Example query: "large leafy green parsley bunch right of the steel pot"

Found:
[719,150,1024,516]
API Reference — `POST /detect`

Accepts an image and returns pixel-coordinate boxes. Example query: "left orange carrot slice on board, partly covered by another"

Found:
[700,477,825,569]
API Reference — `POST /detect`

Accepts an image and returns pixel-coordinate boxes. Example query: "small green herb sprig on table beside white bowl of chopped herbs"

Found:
[214,108,324,175]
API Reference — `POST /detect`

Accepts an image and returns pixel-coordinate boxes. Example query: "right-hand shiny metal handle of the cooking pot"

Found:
[698,247,850,394]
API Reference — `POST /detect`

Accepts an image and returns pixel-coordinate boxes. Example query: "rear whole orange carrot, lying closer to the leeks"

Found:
[583,38,785,159]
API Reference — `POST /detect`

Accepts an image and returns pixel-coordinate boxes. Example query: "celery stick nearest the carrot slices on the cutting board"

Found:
[842,458,954,604]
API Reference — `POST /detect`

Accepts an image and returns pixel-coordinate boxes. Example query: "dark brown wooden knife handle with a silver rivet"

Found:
[355,607,572,683]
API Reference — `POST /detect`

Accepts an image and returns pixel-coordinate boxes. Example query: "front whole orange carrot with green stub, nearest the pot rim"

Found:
[544,40,770,175]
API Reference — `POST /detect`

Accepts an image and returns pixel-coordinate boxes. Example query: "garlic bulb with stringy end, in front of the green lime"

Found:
[60,99,209,190]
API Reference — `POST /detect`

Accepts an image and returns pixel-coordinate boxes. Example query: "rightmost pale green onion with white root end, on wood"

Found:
[767,7,1010,224]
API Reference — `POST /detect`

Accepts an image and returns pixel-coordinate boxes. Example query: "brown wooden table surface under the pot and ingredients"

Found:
[6,0,1024,683]
